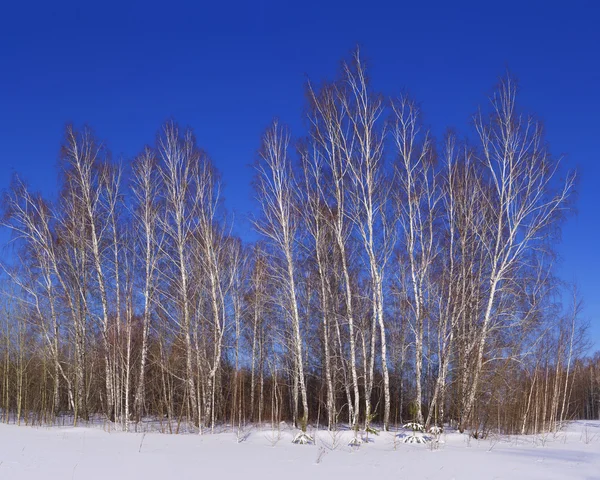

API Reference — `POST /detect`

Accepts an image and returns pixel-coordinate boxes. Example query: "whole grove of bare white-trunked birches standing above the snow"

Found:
[0,50,600,436]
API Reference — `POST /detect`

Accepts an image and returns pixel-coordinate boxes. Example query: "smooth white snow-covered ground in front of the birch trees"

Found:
[0,421,600,480]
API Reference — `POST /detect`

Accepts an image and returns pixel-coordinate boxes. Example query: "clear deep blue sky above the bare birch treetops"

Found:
[0,0,600,348]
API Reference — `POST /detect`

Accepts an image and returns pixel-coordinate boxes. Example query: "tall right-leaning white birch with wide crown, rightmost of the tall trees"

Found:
[461,77,574,430]
